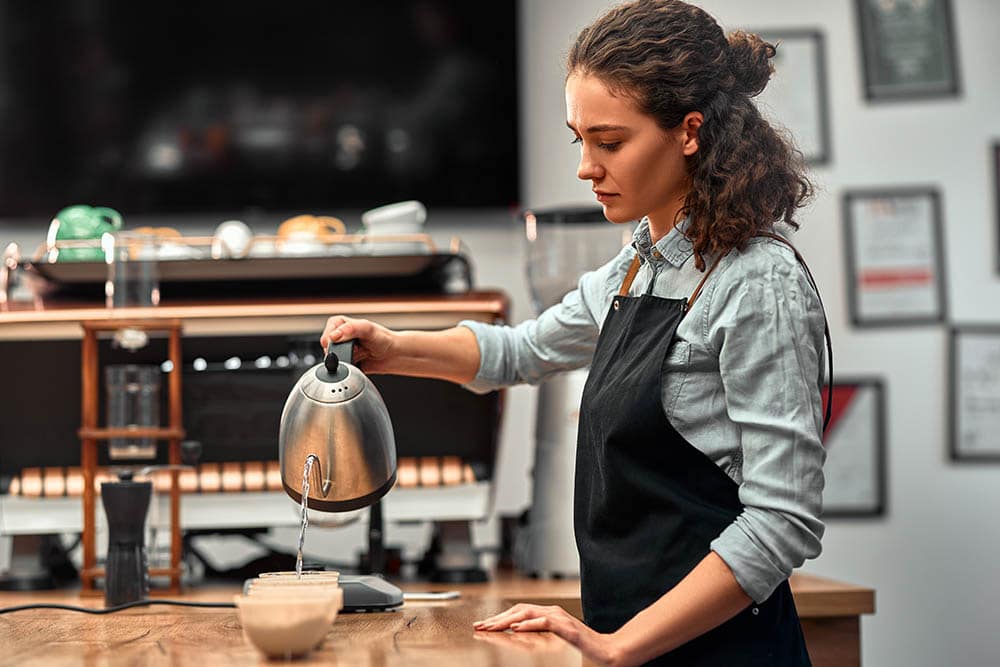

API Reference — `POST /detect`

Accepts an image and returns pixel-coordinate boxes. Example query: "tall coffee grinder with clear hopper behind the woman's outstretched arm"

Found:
[515,206,632,578]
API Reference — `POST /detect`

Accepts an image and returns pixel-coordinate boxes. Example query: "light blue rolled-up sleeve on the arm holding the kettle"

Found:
[459,247,634,393]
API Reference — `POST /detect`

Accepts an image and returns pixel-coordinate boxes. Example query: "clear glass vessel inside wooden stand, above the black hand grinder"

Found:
[104,364,160,460]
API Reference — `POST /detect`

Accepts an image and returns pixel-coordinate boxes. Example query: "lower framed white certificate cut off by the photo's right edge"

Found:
[949,325,1000,463]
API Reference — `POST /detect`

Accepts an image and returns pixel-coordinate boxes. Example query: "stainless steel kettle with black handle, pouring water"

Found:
[278,340,396,512]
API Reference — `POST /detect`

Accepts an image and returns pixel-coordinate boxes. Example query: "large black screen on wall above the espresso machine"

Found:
[0,0,518,217]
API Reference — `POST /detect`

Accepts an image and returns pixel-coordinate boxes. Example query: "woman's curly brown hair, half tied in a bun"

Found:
[567,0,813,270]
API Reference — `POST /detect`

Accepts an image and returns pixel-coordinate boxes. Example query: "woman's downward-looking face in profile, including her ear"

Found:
[566,73,700,233]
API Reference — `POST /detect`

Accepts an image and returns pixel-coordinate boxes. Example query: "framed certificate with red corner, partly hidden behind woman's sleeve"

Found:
[823,378,886,517]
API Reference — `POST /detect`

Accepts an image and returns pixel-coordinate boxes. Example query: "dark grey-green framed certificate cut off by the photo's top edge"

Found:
[856,0,959,100]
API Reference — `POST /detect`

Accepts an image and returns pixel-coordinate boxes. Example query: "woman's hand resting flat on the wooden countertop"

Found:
[472,604,625,667]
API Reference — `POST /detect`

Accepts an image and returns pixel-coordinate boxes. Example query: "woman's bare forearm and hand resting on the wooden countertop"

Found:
[473,551,751,667]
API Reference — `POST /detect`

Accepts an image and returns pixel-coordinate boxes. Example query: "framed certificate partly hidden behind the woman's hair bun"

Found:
[755,30,830,164]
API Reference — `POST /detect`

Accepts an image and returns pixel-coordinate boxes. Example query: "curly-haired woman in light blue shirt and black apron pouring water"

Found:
[322,0,825,666]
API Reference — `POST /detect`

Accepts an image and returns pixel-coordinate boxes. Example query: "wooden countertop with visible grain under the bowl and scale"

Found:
[0,574,874,667]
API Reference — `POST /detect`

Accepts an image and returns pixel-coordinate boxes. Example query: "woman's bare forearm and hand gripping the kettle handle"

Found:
[320,315,479,384]
